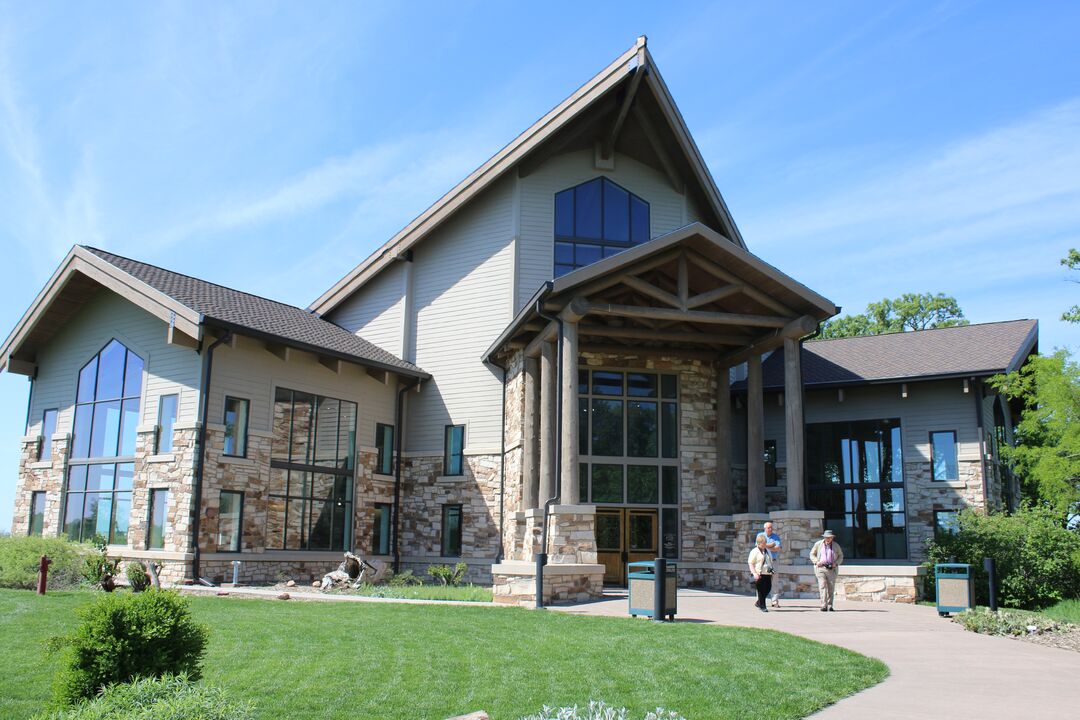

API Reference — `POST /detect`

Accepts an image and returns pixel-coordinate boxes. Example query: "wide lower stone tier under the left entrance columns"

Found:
[491,562,604,607]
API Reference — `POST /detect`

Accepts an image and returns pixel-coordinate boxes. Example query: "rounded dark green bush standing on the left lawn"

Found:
[51,590,210,705]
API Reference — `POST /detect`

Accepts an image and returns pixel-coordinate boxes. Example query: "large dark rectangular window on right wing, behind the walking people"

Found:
[807,419,907,559]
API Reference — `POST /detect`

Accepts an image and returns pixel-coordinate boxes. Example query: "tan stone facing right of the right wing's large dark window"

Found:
[904,460,986,562]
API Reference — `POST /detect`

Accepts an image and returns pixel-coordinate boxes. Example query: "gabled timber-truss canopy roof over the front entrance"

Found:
[484,222,837,367]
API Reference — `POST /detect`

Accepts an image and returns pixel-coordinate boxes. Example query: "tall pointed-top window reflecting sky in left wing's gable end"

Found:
[64,340,143,545]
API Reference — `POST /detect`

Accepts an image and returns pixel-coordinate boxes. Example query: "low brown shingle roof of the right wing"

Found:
[737,320,1039,388]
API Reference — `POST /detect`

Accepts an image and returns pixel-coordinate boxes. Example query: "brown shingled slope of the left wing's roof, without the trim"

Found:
[83,246,427,377]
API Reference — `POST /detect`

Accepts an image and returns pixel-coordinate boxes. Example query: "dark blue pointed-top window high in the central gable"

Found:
[555,177,649,277]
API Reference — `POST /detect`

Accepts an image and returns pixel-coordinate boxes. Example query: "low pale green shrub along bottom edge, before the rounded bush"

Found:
[36,675,255,720]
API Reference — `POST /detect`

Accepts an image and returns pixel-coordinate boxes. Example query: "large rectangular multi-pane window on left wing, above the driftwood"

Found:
[267,388,356,551]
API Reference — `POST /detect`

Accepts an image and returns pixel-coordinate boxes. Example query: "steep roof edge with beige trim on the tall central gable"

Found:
[309,36,746,314]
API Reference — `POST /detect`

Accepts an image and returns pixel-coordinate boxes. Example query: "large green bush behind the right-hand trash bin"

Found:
[927,506,1080,610]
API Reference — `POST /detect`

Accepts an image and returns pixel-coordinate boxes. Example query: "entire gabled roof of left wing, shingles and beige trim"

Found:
[0,245,428,378]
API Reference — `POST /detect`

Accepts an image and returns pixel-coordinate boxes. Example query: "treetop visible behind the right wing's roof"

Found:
[821,291,972,338]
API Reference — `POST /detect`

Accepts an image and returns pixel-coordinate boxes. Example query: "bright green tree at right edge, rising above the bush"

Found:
[990,350,1080,516]
